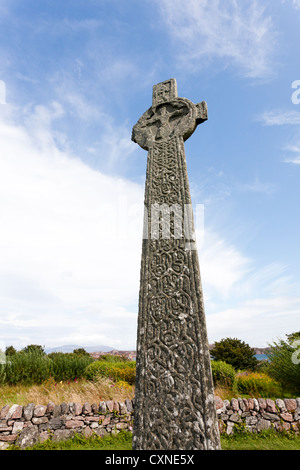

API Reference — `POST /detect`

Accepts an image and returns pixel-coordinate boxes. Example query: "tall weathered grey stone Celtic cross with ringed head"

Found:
[132,79,221,450]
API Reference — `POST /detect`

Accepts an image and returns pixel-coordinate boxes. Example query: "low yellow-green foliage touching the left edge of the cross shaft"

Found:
[85,361,136,385]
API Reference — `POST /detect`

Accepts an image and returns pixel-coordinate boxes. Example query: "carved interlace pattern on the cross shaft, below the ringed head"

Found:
[133,137,219,450]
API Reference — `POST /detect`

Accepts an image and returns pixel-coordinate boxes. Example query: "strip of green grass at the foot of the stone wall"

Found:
[11,431,300,451]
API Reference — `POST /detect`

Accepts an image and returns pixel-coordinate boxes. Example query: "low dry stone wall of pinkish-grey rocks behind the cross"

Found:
[0,397,300,449]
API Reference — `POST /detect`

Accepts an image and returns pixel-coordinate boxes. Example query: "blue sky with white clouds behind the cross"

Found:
[0,0,300,350]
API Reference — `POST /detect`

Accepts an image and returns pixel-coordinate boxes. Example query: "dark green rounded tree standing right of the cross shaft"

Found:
[211,338,258,370]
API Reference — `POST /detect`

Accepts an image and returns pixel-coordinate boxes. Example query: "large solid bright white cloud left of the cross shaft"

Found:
[0,103,144,347]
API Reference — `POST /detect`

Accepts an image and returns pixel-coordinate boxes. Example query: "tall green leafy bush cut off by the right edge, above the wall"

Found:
[266,333,300,395]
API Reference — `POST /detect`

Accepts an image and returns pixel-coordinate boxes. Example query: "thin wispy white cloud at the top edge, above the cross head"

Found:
[157,0,276,78]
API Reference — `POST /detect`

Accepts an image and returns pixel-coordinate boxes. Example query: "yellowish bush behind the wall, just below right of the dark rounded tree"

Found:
[236,372,282,398]
